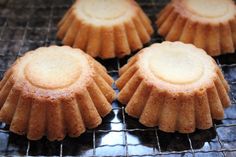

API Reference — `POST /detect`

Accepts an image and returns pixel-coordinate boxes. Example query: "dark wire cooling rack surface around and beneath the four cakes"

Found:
[0,0,236,157]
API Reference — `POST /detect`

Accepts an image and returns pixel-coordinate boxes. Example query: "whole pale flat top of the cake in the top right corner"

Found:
[173,0,236,23]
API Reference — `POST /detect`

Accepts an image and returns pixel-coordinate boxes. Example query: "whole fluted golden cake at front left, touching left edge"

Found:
[0,46,115,141]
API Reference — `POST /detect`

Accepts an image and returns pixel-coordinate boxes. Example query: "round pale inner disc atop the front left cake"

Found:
[24,53,81,89]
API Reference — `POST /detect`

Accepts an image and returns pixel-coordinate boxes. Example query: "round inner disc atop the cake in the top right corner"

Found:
[186,0,229,18]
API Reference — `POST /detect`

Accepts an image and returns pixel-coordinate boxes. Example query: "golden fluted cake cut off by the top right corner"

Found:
[156,0,236,56]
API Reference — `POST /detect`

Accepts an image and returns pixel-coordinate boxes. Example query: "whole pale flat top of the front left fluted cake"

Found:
[12,46,95,97]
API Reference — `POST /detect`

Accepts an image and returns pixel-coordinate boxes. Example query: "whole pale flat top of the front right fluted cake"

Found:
[138,41,217,91]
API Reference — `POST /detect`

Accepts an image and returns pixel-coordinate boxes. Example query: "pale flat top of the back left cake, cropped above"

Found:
[74,0,136,25]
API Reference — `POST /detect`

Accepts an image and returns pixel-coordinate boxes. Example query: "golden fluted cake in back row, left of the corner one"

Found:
[57,0,153,59]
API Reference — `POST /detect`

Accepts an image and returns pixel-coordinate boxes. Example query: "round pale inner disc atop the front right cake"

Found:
[149,48,203,84]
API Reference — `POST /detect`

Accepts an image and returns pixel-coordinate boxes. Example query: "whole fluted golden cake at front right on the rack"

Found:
[116,41,230,133]
